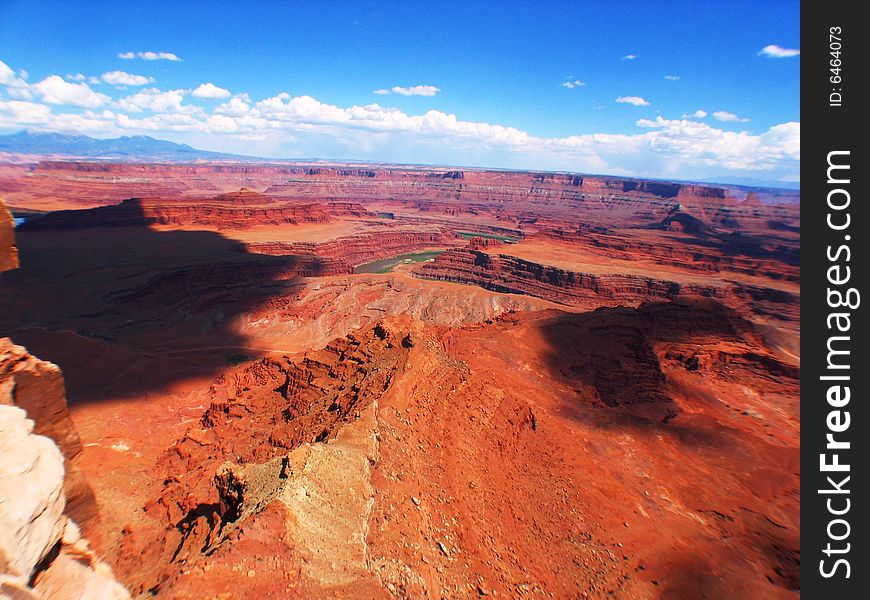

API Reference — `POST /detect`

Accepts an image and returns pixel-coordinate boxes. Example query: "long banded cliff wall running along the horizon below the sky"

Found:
[2,161,799,218]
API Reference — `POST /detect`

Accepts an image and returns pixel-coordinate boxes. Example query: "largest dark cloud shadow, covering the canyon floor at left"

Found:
[0,200,322,404]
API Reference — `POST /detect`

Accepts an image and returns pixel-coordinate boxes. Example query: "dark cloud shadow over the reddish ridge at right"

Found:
[542,299,798,447]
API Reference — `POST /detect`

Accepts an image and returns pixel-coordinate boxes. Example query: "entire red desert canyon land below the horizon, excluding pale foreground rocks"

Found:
[0,160,800,599]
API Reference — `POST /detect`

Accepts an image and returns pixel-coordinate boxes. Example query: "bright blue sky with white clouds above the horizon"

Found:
[0,0,800,181]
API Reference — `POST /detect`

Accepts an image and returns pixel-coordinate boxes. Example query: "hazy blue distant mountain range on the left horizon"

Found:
[0,130,245,162]
